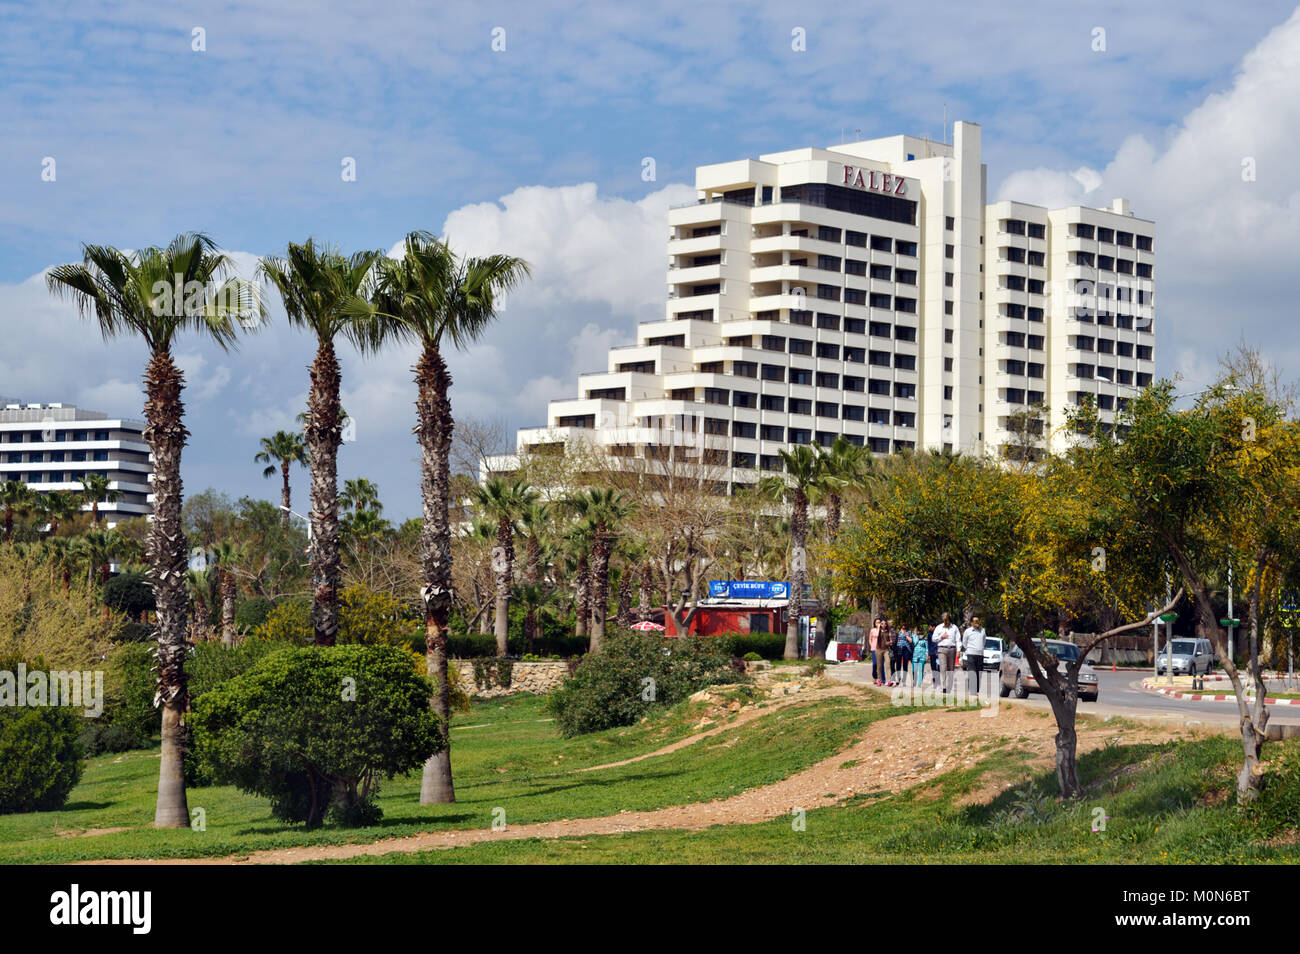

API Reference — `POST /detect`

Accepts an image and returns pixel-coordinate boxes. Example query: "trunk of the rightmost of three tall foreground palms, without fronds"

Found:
[415,343,456,805]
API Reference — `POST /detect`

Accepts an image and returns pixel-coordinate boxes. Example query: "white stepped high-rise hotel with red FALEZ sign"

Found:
[501,122,1154,489]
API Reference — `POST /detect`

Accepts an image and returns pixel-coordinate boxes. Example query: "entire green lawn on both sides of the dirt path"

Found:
[0,690,1300,864]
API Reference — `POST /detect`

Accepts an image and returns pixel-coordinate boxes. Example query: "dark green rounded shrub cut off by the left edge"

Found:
[0,658,85,815]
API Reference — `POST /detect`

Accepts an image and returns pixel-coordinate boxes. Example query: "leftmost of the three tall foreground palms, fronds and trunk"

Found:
[46,234,265,828]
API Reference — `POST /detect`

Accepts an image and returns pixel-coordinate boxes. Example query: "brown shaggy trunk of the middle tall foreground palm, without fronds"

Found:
[307,341,342,646]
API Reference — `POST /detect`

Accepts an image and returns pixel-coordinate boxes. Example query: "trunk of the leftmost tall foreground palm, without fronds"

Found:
[144,351,190,828]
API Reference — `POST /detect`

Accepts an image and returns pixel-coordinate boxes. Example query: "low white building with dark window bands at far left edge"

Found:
[0,399,153,526]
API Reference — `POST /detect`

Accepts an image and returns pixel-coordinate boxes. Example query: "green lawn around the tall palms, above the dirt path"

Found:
[0,690,901,863]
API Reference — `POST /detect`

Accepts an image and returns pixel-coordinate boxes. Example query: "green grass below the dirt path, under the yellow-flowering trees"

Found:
[332,738,1300,864]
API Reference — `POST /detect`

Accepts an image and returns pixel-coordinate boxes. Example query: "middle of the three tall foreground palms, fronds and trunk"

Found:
[257,239,380,646]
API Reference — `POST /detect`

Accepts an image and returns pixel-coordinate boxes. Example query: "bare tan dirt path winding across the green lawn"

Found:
[76,690,1178,864]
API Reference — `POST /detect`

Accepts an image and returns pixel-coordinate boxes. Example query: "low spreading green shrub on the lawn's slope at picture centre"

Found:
[549,633,744,738]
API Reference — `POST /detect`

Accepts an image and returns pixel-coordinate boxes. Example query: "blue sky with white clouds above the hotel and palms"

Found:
[0,0,1300,517]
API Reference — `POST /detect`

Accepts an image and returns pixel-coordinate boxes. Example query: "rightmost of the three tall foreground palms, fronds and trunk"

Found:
[351,231,528,805]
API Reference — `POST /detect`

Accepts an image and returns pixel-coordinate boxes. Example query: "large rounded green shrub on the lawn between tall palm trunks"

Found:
[190,645,447,827]
